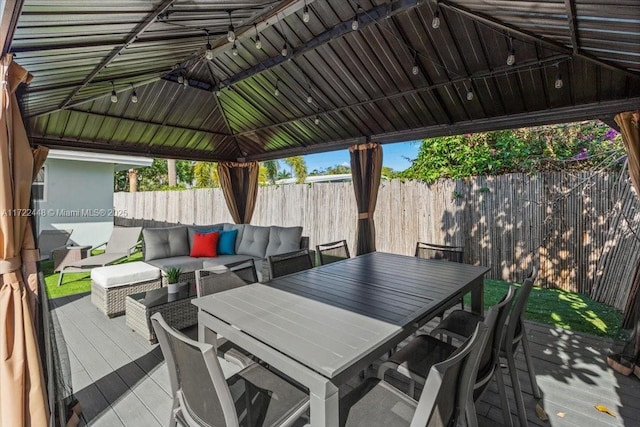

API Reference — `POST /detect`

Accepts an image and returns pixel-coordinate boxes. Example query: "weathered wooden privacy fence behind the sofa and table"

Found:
[114,172,640,310]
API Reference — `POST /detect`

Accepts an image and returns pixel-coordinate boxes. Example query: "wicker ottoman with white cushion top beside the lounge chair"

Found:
[91,261,162,317]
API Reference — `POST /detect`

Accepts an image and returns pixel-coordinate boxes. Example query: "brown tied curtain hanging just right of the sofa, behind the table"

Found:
[349,142,382,255]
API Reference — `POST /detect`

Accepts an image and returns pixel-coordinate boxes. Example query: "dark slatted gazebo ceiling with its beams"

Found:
[2,0,640,160]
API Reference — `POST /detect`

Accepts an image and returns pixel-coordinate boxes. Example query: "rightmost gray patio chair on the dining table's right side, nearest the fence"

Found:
[434,267,542,426]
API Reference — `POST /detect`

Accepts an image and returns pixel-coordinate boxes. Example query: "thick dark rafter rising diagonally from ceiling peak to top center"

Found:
[220,0,417,86]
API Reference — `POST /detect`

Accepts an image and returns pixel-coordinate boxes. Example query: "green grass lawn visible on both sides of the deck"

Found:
[41,251,623,338]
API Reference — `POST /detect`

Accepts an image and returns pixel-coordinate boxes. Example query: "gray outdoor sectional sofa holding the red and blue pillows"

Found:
[142,223,309,281]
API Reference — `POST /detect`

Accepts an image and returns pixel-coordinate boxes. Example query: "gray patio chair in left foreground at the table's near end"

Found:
[151,313,309,427]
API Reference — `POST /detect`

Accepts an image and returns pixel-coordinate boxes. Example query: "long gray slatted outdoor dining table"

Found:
[193,252,488,427]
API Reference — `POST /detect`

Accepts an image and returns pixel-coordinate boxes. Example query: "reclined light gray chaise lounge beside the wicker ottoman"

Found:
[58,227,142,286]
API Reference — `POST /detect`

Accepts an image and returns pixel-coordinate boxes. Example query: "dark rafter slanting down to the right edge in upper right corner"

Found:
[438,0,640,78]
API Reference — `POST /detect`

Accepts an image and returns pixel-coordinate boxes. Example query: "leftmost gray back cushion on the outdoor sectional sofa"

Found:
[142,225,189,261]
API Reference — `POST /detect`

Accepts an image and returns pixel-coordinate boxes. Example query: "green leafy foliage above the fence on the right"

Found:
[398,121,624,183]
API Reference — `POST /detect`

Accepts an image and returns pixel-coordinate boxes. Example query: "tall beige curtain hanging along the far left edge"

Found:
[0,55,49,427]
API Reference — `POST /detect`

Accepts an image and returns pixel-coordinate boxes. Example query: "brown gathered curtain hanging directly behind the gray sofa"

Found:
[218,162,259,224]
